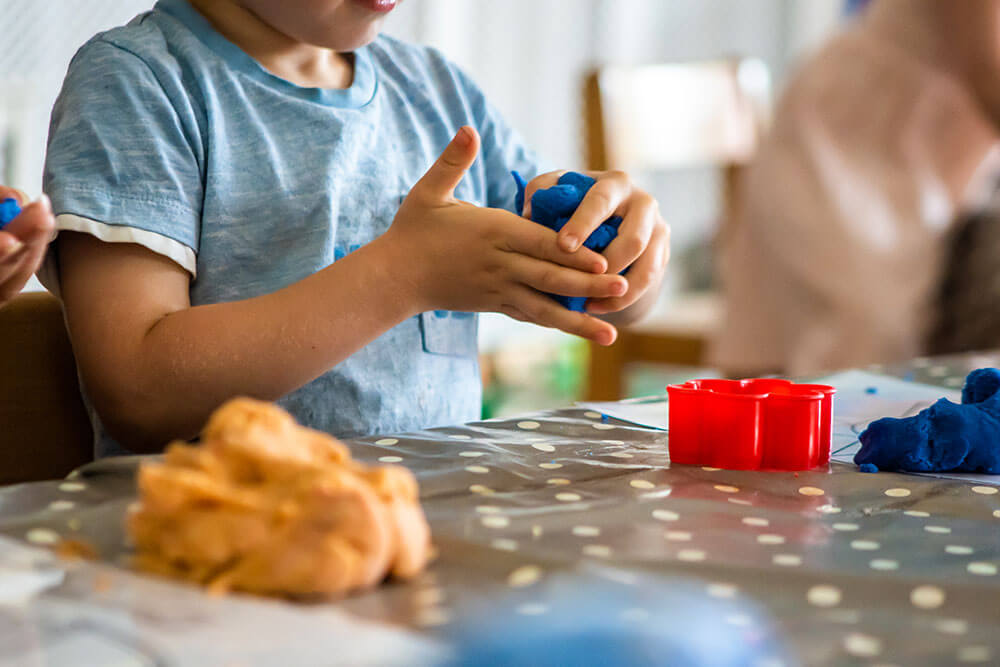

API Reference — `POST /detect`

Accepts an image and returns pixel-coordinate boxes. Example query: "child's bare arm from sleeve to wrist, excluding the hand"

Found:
[61,231,419,451]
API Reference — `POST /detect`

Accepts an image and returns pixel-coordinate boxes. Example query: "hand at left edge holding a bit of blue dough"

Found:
[0,186,55,305]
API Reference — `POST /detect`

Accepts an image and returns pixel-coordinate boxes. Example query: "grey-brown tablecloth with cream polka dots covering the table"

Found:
[0,357,1000,665]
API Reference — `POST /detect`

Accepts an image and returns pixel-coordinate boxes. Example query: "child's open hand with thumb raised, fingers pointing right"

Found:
[380,126,628,345]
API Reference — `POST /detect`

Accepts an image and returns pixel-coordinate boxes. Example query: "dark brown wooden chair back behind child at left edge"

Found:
[0,292,94,484]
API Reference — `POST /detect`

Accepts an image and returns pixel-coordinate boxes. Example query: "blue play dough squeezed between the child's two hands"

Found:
[511,171,625,313]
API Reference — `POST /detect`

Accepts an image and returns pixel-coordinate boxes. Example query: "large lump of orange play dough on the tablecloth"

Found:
[128,398,431,597]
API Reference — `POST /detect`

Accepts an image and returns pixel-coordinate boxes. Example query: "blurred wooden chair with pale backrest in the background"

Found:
[584,59,771,400]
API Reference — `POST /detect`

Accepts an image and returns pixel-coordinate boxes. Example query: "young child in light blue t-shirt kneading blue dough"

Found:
[41,0,668,455]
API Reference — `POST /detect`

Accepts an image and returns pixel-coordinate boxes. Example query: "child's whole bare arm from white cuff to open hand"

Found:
[58,128,628,451]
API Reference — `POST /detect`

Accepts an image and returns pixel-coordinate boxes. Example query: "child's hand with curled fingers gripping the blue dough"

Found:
[521,171,670,319]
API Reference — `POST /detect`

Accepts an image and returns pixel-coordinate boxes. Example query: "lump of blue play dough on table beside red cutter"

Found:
[854,368,1000,474]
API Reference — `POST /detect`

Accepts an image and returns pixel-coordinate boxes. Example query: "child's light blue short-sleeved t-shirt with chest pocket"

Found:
[44,0,537,456]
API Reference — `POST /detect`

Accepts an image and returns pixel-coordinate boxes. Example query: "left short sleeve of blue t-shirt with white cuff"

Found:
[40,39,203,291]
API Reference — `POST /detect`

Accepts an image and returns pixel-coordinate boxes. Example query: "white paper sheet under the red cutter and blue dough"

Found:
[578,371,1000,485]
